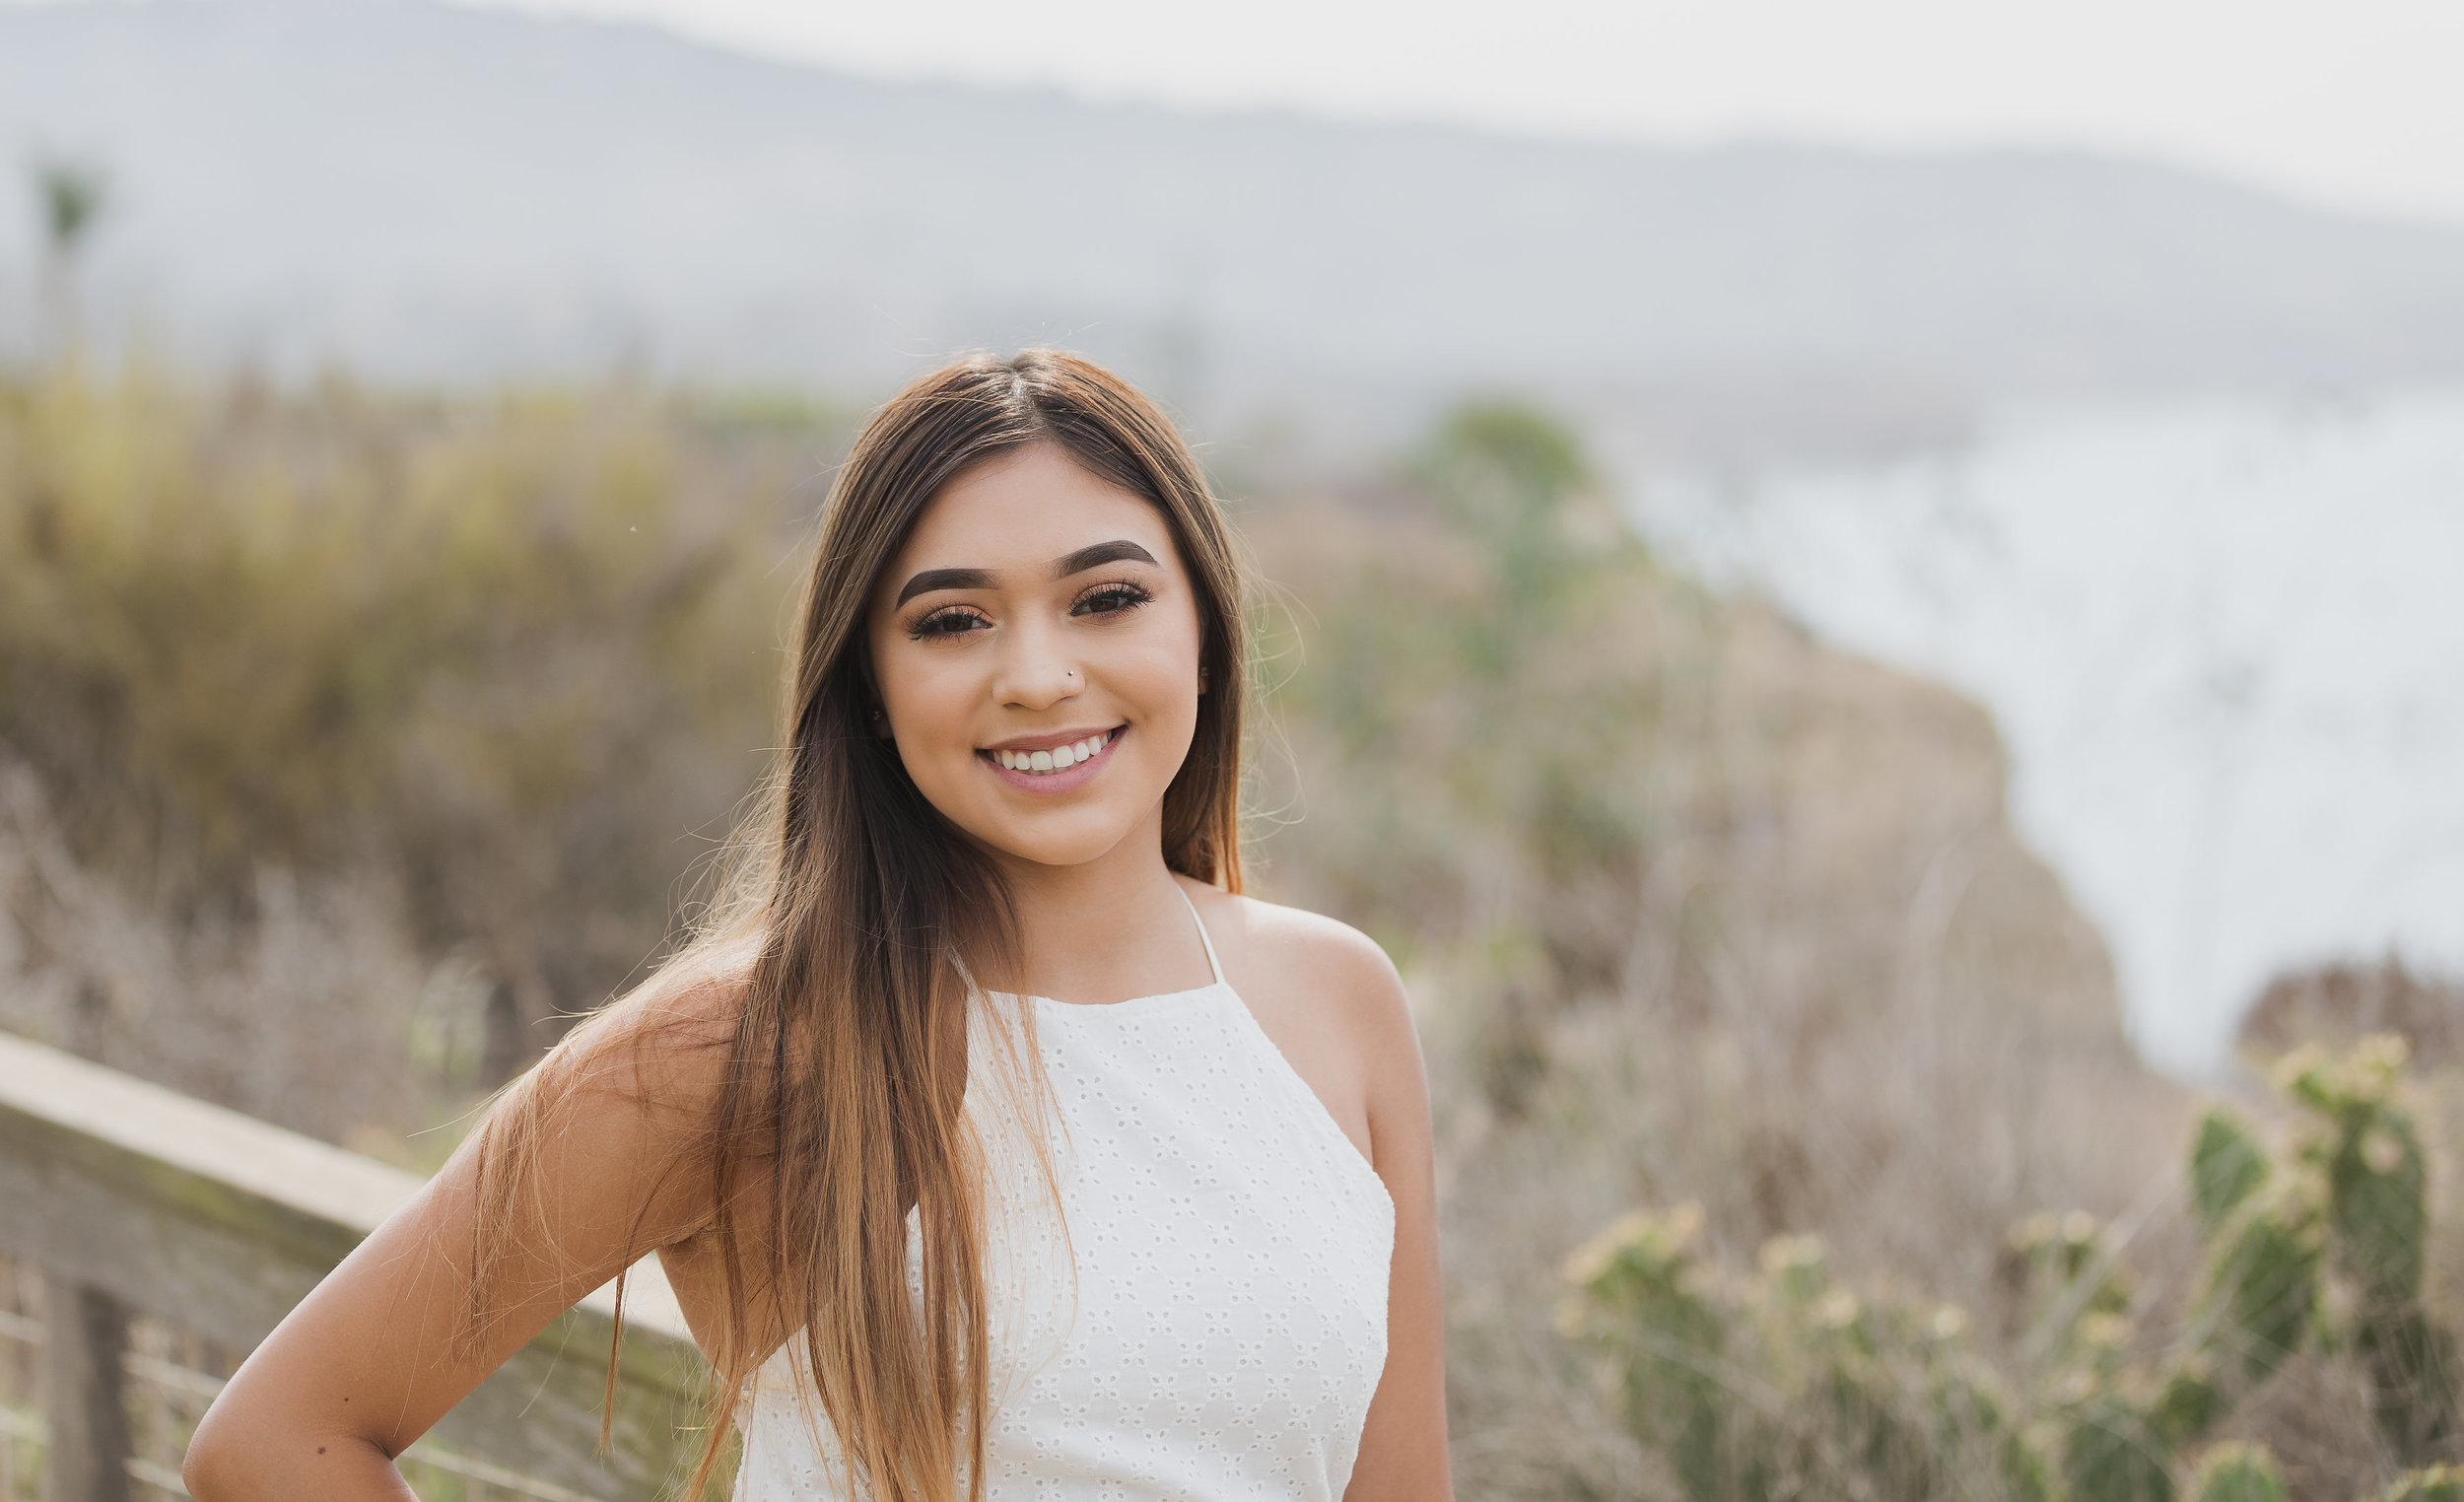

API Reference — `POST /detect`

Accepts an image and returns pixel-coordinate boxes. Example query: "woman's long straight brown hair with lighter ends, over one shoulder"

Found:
[473,350,1247,1502]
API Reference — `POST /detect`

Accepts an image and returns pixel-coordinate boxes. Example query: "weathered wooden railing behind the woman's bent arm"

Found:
[0,1034,700,1502]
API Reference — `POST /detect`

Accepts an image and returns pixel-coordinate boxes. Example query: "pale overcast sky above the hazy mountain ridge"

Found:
[465,0,2464,222]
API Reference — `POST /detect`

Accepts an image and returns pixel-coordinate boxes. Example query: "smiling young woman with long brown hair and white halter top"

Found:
[187,350,1452,1502]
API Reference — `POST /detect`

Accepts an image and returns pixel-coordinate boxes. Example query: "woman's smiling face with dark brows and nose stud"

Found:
[870,444,1200,866]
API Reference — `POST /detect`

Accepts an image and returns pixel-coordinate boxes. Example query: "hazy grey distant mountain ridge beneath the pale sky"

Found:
[0,0,2464,450]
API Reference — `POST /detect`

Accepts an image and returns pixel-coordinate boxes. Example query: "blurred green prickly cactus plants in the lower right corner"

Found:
[1562,1037,2457,1502]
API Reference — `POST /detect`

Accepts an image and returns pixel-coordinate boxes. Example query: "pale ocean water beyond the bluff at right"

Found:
[1631,391,2464,1076]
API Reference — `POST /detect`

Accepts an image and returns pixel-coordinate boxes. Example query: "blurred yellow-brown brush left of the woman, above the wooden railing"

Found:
[0,372,846,1157]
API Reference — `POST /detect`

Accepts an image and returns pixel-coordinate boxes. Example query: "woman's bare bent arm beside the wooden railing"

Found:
[182,960,734,1502]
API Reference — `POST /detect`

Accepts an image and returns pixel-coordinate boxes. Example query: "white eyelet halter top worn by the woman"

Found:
[734,894,1395,1502]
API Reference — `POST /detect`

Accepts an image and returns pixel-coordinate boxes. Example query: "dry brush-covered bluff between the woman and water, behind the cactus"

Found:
[1252,418,2188,1497]
